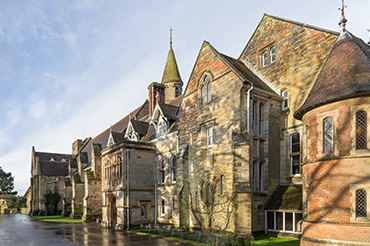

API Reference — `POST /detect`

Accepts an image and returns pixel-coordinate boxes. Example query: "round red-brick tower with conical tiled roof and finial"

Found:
[294,12,370,245]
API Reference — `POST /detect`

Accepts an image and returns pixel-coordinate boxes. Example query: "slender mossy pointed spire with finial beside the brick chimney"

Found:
[161,27,183,85]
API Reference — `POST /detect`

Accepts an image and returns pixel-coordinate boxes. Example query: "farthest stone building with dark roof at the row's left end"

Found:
[29,147,71,215]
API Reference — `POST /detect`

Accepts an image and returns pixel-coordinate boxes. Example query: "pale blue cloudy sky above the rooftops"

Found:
[0,0,370,195]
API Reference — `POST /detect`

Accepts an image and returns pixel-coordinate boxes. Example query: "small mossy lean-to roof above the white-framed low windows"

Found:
[265,184,302,210]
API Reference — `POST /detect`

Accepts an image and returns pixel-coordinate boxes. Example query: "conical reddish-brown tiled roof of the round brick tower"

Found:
[294,32,370,120]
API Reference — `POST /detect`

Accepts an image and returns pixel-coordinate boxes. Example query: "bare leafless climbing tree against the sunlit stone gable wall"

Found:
[189,177,236,233]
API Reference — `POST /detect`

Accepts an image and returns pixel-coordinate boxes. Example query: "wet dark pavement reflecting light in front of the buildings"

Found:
[0,214,190,246]
